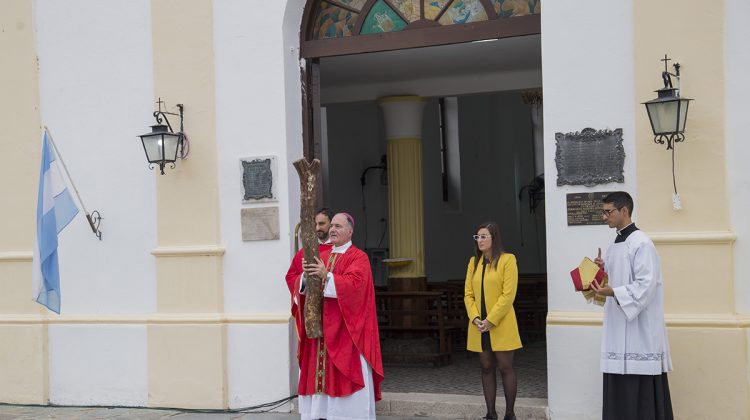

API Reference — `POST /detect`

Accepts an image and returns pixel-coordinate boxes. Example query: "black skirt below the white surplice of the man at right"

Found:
[602,373,674,420]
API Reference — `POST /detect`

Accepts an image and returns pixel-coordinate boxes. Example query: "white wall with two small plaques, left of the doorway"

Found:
[213,0,302,407]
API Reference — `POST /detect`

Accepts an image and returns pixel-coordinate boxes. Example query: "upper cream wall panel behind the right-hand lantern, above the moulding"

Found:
[633,0,729,232]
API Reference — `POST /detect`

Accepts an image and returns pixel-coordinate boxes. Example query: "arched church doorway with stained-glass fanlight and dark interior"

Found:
[302,0,547,404]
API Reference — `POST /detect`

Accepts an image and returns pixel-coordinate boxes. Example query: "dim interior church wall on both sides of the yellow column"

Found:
[325,91,545,281]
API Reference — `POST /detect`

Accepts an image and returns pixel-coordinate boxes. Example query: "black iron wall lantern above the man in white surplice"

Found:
[643,54,692,150]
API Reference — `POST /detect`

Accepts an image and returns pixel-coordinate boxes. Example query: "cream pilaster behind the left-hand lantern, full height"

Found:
[148,0,227,408]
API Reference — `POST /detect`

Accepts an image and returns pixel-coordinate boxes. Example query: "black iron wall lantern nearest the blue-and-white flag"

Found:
[139,98,190,175]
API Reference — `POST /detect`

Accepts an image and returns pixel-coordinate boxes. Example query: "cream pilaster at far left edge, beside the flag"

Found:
[0,0,49,404]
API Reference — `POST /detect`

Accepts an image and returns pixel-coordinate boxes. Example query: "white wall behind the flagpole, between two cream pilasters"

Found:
[36,0,157,405]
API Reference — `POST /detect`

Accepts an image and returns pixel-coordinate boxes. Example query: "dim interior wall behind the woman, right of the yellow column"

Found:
[440,91,546,278]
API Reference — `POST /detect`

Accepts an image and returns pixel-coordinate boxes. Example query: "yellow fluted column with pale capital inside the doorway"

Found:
[378,96,425,288]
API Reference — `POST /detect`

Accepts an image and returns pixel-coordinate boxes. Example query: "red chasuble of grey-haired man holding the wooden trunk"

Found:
[293,245,383,401]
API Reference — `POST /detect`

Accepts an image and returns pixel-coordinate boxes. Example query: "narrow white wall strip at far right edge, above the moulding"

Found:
[724,0,750,316]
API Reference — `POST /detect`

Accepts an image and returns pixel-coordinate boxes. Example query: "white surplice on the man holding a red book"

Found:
[601,226,672,375]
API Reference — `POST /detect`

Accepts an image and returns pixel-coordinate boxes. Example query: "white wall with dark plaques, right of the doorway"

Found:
[541,0,645,419]
